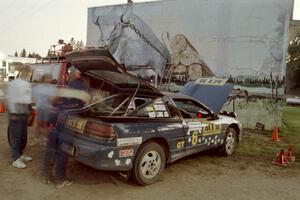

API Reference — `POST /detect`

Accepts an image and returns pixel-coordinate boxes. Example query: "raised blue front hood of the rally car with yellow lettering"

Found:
[179,78,234,113]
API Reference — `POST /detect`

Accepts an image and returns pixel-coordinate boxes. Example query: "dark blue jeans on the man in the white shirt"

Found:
[8,113,29,161]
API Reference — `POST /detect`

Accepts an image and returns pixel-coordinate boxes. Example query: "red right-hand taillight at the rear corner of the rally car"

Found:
[85,121,117,139]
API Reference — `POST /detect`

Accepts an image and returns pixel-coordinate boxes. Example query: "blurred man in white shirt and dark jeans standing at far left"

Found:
[7,66,32,169]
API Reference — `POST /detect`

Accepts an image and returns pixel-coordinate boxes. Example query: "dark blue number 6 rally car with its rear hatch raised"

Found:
[58,49,242,185]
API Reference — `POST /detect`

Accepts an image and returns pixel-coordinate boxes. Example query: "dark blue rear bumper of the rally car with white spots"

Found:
[60,133,136,171]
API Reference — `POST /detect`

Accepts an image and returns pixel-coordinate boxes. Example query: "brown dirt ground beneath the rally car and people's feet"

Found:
[0,114,300,200]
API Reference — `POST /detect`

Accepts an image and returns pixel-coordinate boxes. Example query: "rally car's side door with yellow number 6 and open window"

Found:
[173,98,222,155]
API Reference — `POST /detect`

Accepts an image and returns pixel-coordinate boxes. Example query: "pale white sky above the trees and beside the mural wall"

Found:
[0,0,300,56]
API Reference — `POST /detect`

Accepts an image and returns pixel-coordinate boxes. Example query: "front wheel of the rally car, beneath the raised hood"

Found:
[221,128,237,156]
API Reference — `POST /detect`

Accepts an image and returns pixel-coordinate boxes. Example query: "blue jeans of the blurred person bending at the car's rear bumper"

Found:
[43,128,68,181]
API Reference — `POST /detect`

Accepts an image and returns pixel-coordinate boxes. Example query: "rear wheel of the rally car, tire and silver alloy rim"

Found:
[132,142,166,185]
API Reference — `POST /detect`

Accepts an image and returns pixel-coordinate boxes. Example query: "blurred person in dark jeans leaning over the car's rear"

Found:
[43,68,88,188]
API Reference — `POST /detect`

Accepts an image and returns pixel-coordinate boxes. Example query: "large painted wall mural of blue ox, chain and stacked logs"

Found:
[87,0,292,129]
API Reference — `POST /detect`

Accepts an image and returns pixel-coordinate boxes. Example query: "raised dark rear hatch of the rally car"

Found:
[66,48,162,96]
